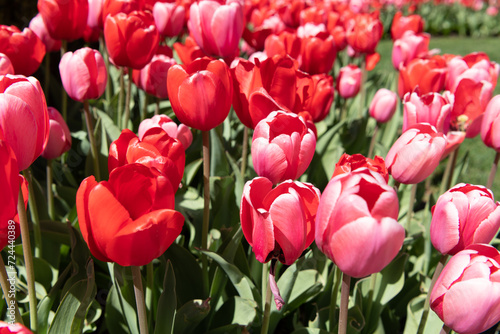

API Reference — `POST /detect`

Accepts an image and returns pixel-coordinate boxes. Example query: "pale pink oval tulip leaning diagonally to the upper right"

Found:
[385,123,447,184]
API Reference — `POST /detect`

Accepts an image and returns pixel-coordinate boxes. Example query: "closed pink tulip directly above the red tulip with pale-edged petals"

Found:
[252,111,316,184]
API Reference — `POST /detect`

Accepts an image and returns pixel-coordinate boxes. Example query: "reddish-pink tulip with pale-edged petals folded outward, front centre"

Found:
[240,177,320,265]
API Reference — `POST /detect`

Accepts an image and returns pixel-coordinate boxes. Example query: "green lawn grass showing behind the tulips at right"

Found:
[375,36,500,199]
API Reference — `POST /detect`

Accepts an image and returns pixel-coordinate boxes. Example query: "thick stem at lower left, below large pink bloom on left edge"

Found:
[17,182,38,332]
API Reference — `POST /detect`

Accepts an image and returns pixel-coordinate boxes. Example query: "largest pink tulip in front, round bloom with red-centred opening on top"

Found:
[316,168,405,277]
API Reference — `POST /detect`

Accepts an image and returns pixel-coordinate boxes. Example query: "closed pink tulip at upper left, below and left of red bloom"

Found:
[59,47,108,102]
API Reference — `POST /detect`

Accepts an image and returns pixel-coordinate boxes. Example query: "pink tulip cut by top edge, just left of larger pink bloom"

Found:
[153,2,186,37]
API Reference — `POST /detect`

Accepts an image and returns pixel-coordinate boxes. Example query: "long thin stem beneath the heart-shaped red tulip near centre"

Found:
[201,131,210,291]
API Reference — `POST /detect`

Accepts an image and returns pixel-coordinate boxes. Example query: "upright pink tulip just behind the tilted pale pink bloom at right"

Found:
[403,90,452,133]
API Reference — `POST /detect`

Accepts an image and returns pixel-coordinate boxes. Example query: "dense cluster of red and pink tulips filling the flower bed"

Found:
[0,0,500,333]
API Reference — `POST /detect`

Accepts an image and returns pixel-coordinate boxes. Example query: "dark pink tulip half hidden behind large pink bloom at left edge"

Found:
[42,107,71,159]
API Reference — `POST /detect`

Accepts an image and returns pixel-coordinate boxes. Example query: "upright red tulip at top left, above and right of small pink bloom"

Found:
[104,11,160,70]
